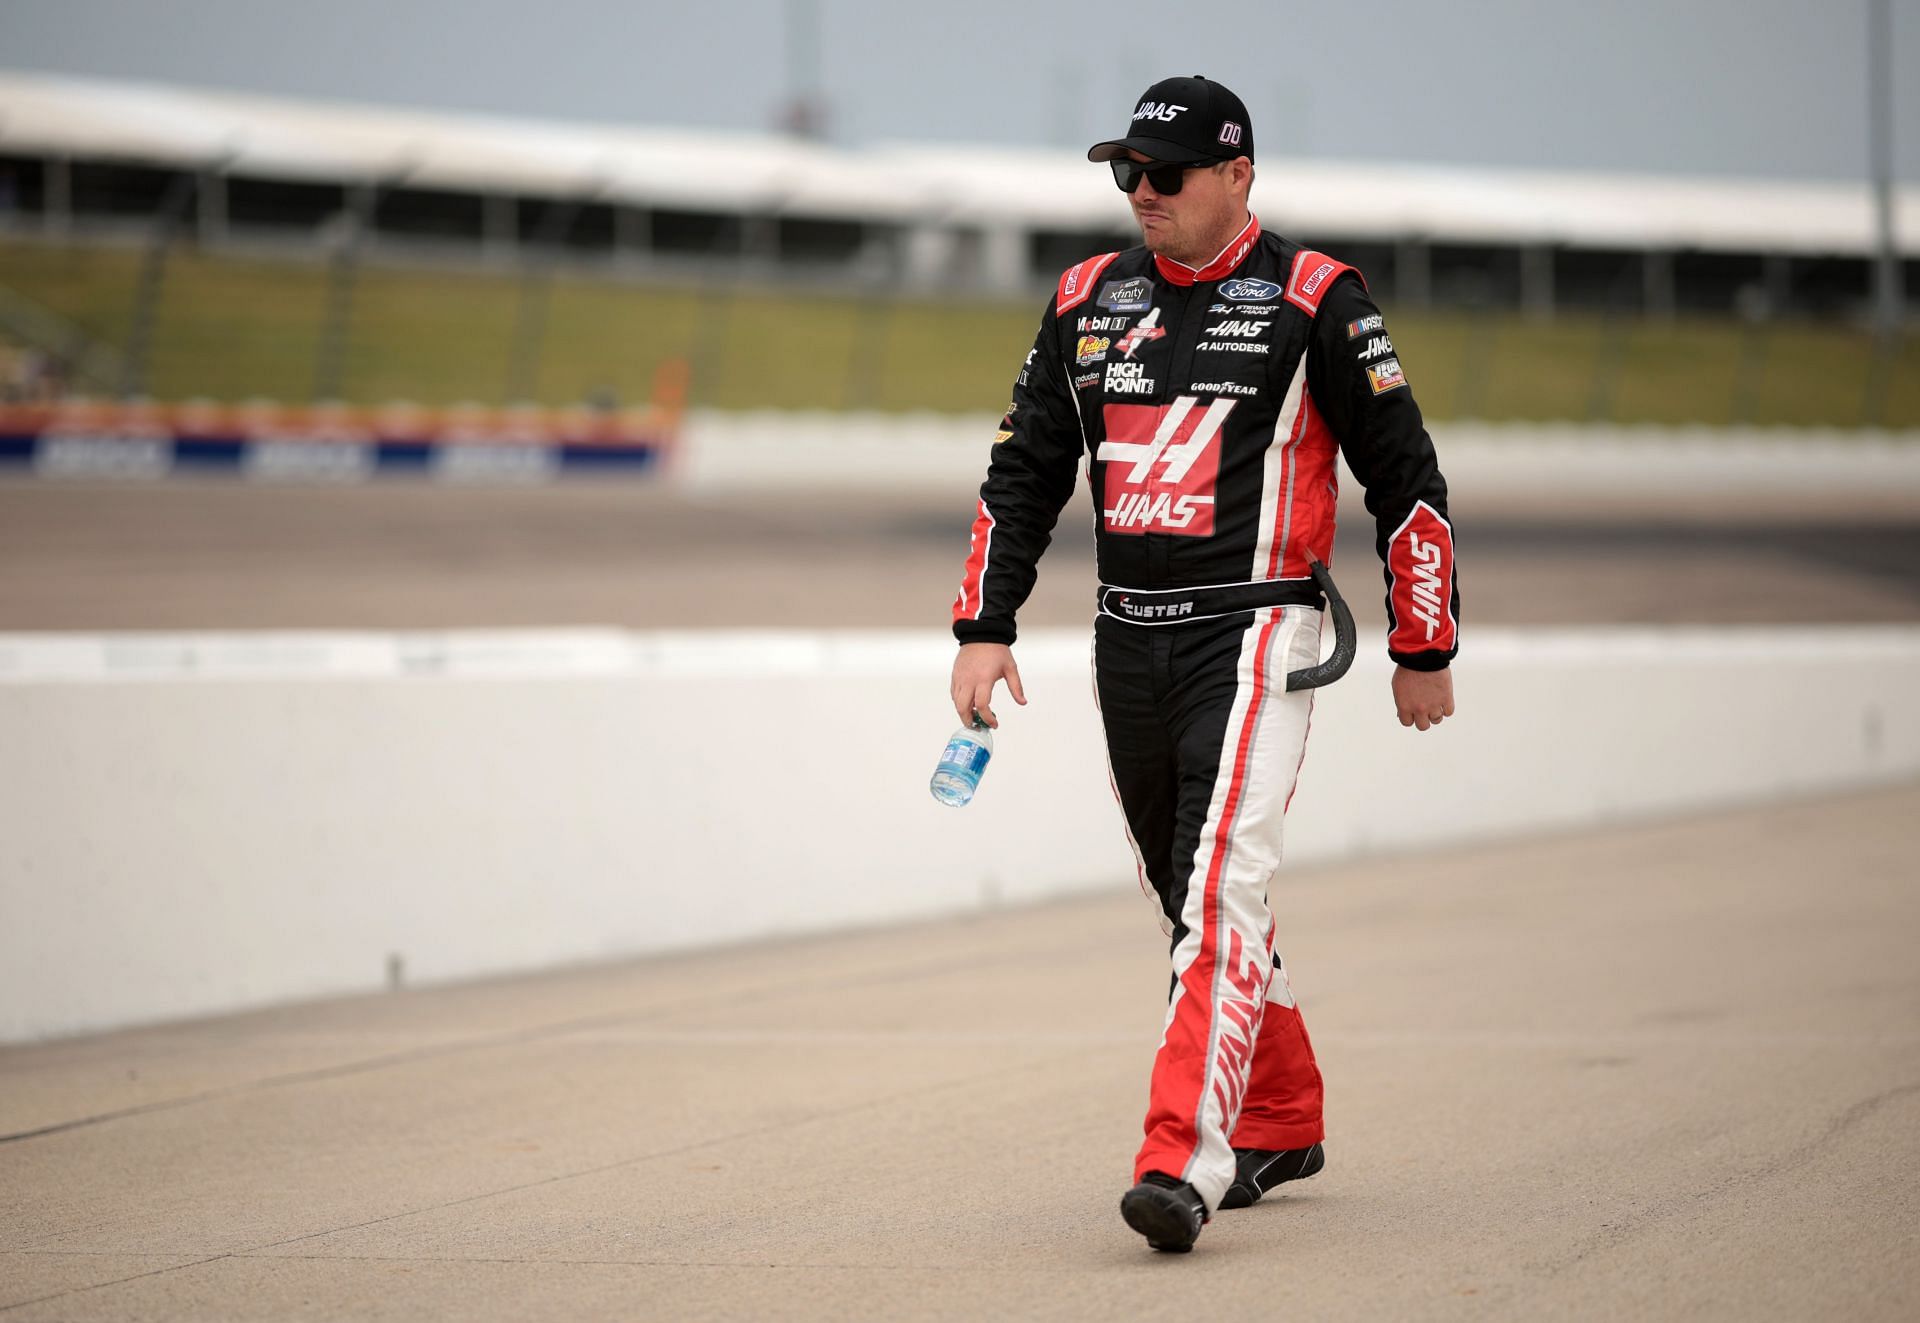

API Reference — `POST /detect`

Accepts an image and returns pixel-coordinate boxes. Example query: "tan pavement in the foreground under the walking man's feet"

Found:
[0,791,1920,1323]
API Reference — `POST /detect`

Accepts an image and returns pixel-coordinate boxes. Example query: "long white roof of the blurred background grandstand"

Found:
[0,71,1920,255]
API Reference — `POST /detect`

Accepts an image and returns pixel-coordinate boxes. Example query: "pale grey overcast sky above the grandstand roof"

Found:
[0,0,1920,180]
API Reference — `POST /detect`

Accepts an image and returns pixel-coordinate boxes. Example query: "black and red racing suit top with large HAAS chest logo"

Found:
[952,219,1459,670]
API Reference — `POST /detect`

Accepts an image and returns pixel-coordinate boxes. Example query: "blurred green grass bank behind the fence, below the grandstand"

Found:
[0,242,1920,428]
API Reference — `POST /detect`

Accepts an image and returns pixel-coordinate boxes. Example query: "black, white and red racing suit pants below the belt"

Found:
[1094,607,1325,1208]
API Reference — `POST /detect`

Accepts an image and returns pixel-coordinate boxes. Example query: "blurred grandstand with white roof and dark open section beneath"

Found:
[0,73,1920,321]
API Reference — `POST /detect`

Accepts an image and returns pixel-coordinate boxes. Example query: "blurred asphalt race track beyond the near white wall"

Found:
[0,478,1920,629]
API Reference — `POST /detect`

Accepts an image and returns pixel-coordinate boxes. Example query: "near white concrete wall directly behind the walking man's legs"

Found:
[0,628,1920,1041]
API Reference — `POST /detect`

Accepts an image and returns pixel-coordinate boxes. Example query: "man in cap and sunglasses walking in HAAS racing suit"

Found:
[952,77,1459,1250]
